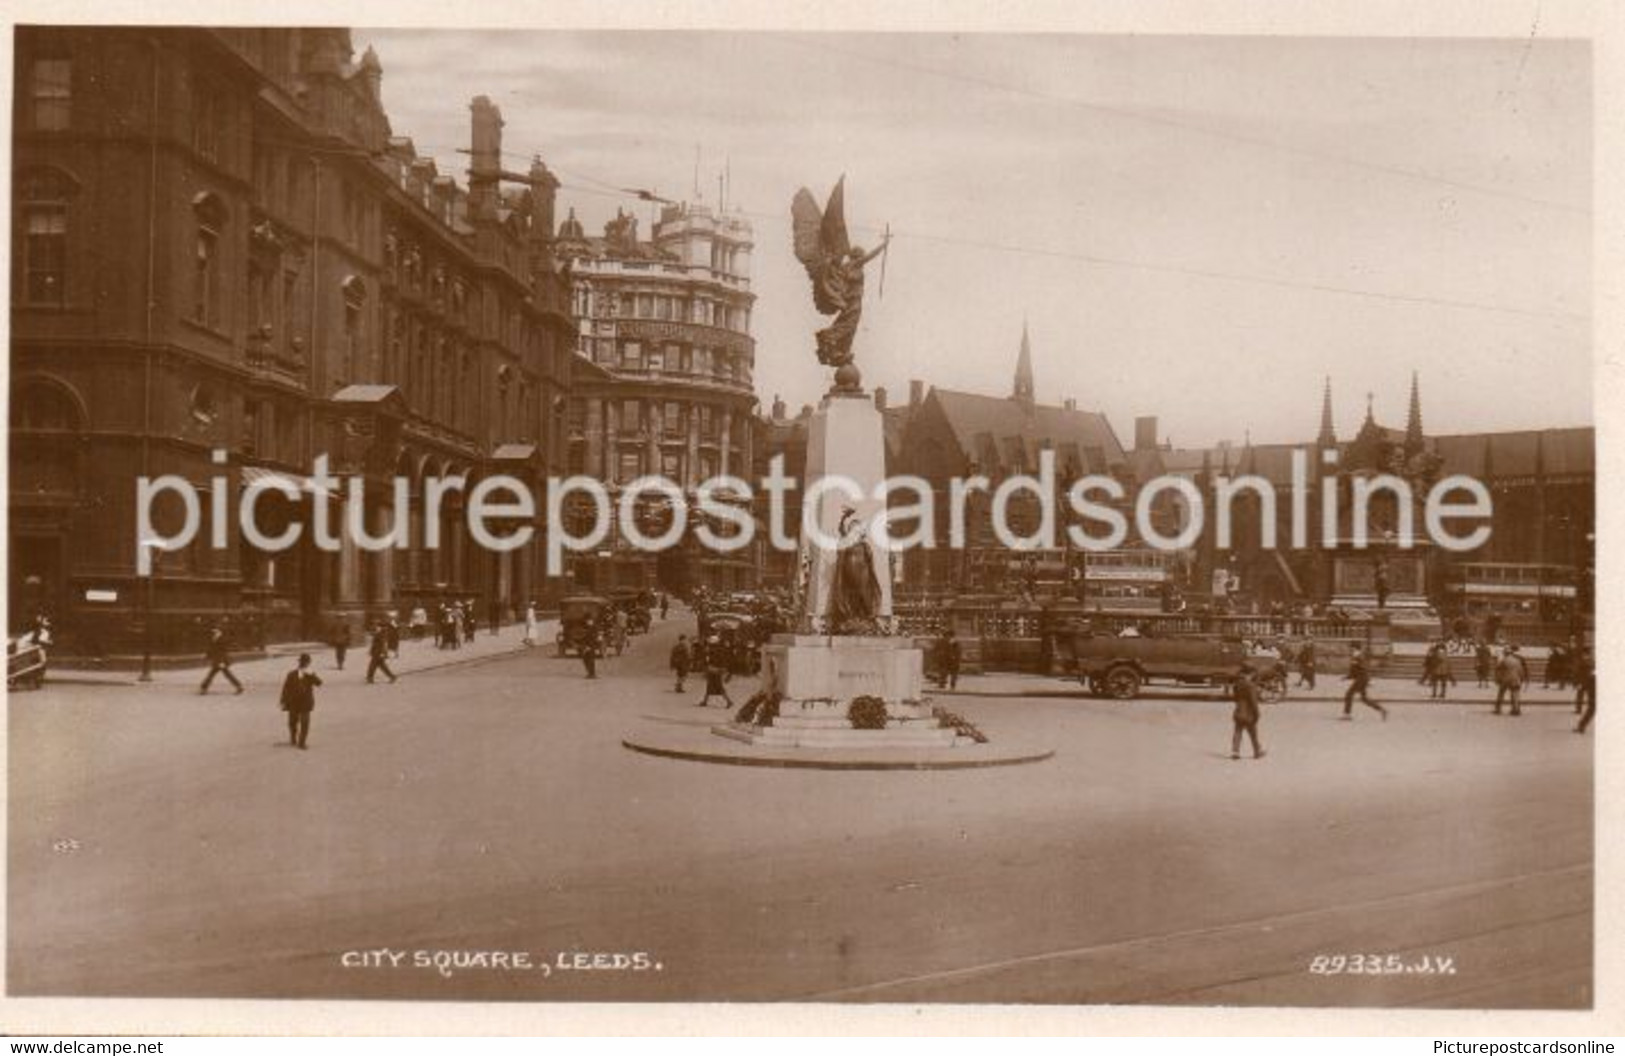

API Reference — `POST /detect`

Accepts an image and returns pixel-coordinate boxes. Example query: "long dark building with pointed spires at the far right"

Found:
[1131,377,1596,624]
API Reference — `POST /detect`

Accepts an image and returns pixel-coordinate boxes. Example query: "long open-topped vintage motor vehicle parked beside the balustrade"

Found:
[1073,634,1287,703]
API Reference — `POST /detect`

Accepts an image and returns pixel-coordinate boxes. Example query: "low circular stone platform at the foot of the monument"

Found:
[621,723,1055,770]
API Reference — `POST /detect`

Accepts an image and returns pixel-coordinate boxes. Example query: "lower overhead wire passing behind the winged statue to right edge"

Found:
[403,143,1591,322]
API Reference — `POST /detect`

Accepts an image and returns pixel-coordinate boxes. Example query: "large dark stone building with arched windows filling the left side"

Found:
[8,28,574,653]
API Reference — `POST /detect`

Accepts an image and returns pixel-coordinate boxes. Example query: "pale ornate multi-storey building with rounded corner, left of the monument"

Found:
[554,203,761,593]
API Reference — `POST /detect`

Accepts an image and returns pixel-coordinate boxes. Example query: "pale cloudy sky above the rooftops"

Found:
[354,29,1593,445]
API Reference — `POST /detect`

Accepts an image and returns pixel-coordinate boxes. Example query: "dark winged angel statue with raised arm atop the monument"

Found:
[790,175,891,390]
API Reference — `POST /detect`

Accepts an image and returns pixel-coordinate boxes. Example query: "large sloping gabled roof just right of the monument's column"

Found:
[926,388,1125,473]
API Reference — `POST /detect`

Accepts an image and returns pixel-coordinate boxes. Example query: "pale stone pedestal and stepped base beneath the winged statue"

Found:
[713,393,970,749]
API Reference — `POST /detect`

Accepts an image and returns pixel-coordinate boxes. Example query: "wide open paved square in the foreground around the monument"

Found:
[8,617,1593,1007]
